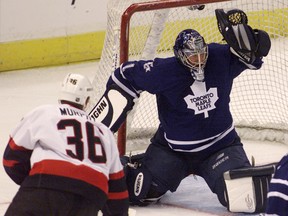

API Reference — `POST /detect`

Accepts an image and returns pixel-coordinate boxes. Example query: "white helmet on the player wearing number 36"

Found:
[59,73,93,109]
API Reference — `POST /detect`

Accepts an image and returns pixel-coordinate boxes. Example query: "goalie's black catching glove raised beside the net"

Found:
[215,9,271,64]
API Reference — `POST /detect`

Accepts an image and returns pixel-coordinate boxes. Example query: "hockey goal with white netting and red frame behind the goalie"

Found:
[90,0,288,154]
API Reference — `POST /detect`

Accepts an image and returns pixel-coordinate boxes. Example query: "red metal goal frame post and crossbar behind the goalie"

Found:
[117,0,231,155]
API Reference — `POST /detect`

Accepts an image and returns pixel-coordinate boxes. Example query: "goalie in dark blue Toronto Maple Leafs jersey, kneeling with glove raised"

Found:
[91,9,274,213]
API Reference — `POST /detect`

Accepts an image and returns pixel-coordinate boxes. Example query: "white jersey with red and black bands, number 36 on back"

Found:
[3,105,128,213]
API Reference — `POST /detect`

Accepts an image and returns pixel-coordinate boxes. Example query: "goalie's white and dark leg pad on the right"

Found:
[224,165,275,213]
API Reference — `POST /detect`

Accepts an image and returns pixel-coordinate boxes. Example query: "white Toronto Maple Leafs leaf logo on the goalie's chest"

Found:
[184,81,218,118]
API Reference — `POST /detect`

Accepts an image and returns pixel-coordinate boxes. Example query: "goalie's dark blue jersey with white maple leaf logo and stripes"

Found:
[108,43,262,152]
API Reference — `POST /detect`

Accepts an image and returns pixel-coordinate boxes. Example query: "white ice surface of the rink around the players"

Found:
[0,62,288,216]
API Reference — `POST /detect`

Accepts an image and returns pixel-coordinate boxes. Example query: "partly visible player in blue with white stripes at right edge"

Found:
[265,155,288,216]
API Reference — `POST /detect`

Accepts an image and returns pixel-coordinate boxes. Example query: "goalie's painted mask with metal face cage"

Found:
[173,29,208,81]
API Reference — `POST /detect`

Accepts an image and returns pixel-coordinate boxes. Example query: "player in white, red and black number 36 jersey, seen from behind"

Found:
[3,74,129,216]
